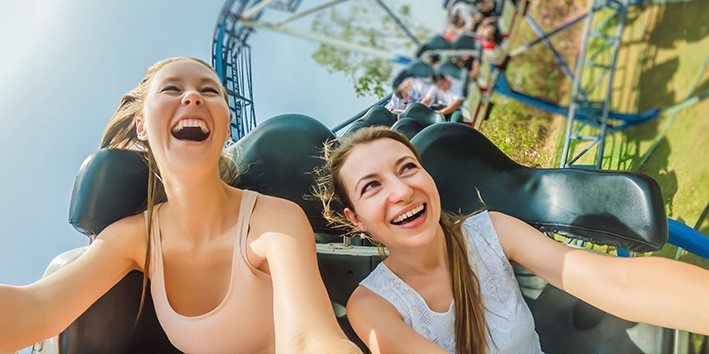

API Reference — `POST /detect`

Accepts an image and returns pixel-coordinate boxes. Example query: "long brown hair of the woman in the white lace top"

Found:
[314,127,488,353]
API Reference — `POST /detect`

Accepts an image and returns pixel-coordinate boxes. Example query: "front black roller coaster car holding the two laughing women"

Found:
[44,114,667,353]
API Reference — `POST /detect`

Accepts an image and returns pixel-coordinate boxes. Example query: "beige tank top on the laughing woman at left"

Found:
[150,190,275,353]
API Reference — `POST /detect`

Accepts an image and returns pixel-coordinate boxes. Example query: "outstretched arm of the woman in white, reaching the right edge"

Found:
[490,212,709,335]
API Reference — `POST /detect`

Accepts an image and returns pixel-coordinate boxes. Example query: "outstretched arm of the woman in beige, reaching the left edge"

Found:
[0,214,145,352]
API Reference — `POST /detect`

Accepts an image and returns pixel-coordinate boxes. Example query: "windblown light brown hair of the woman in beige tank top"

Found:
[101,57,237,324]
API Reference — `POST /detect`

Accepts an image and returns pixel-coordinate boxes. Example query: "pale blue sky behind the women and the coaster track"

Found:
[0,0,443,285]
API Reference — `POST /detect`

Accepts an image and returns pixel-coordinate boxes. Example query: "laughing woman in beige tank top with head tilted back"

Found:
[0,58,359,353]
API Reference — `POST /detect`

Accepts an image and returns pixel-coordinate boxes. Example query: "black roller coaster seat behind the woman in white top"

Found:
[412,123,673,353]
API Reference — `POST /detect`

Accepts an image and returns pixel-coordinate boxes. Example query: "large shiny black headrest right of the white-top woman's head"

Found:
[412,123,668,252]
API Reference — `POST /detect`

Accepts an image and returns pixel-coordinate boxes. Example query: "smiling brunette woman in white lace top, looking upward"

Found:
[316,128,709,353]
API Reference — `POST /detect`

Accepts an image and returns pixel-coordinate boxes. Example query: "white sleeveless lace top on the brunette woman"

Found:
[360,211,541,353]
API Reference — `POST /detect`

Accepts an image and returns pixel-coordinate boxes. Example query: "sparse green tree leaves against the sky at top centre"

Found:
[311,0,430,98]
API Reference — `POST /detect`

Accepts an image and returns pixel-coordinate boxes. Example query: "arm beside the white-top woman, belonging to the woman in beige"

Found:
[250,195,361,353]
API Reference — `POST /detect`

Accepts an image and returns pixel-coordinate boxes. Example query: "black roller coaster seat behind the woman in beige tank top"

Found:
[59,114,334,353]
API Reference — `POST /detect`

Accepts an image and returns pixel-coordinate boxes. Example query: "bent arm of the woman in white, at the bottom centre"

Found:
[347,285,447,354]
